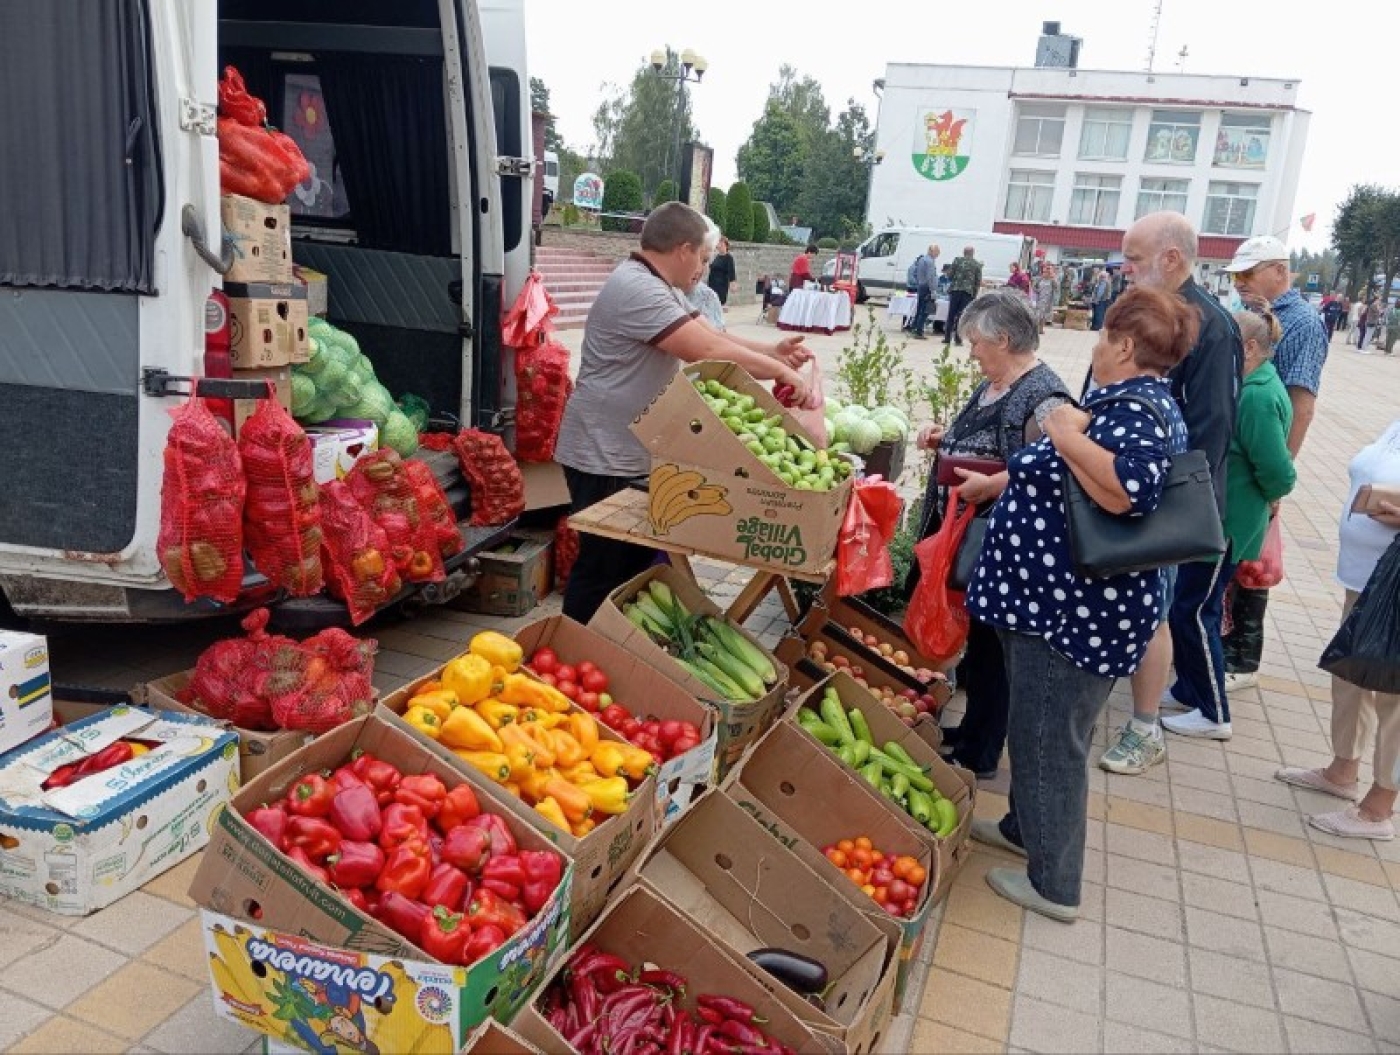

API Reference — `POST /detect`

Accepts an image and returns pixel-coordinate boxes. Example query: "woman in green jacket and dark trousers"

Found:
[1224,312,1298,688]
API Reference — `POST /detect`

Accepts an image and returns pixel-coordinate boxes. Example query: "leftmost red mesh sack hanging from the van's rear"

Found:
[155,397,246,604]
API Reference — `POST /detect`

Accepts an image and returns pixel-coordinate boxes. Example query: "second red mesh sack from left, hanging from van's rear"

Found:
[238,399,325,597]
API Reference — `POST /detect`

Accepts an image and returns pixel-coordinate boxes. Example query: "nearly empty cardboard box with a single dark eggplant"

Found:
[633,791,899,1052]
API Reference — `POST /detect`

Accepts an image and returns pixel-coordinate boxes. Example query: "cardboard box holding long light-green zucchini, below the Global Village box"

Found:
[588,562,788,777]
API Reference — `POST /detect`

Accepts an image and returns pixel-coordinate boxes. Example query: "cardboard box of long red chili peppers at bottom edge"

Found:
[511,887,823,1055]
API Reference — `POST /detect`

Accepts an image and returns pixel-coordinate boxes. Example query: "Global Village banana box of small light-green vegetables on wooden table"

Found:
[631,362,853,575]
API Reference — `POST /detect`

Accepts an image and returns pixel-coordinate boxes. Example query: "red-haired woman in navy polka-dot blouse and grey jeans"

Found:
[967,288,1201,922]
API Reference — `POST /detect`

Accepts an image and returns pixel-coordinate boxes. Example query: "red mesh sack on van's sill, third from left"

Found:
[321,480,403,625]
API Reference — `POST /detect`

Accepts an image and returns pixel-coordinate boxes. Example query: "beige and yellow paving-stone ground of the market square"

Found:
[0,309,1400,1052]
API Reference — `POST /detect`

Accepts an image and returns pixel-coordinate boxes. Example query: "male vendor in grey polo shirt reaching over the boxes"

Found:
[554,201,812,623]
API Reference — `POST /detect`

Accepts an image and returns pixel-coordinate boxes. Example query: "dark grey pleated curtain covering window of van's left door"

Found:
[0,0,161,294]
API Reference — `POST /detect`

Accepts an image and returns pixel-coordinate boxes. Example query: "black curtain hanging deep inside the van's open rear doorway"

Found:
[315,52,452,256]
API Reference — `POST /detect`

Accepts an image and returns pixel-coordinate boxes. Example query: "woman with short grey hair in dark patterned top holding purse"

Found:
[907,290,1070,779]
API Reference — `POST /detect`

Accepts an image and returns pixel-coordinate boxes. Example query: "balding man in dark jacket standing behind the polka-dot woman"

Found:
[1099,211,1245,774]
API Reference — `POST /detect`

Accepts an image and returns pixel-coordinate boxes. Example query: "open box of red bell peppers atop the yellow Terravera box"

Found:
[190,715,574,1035]
